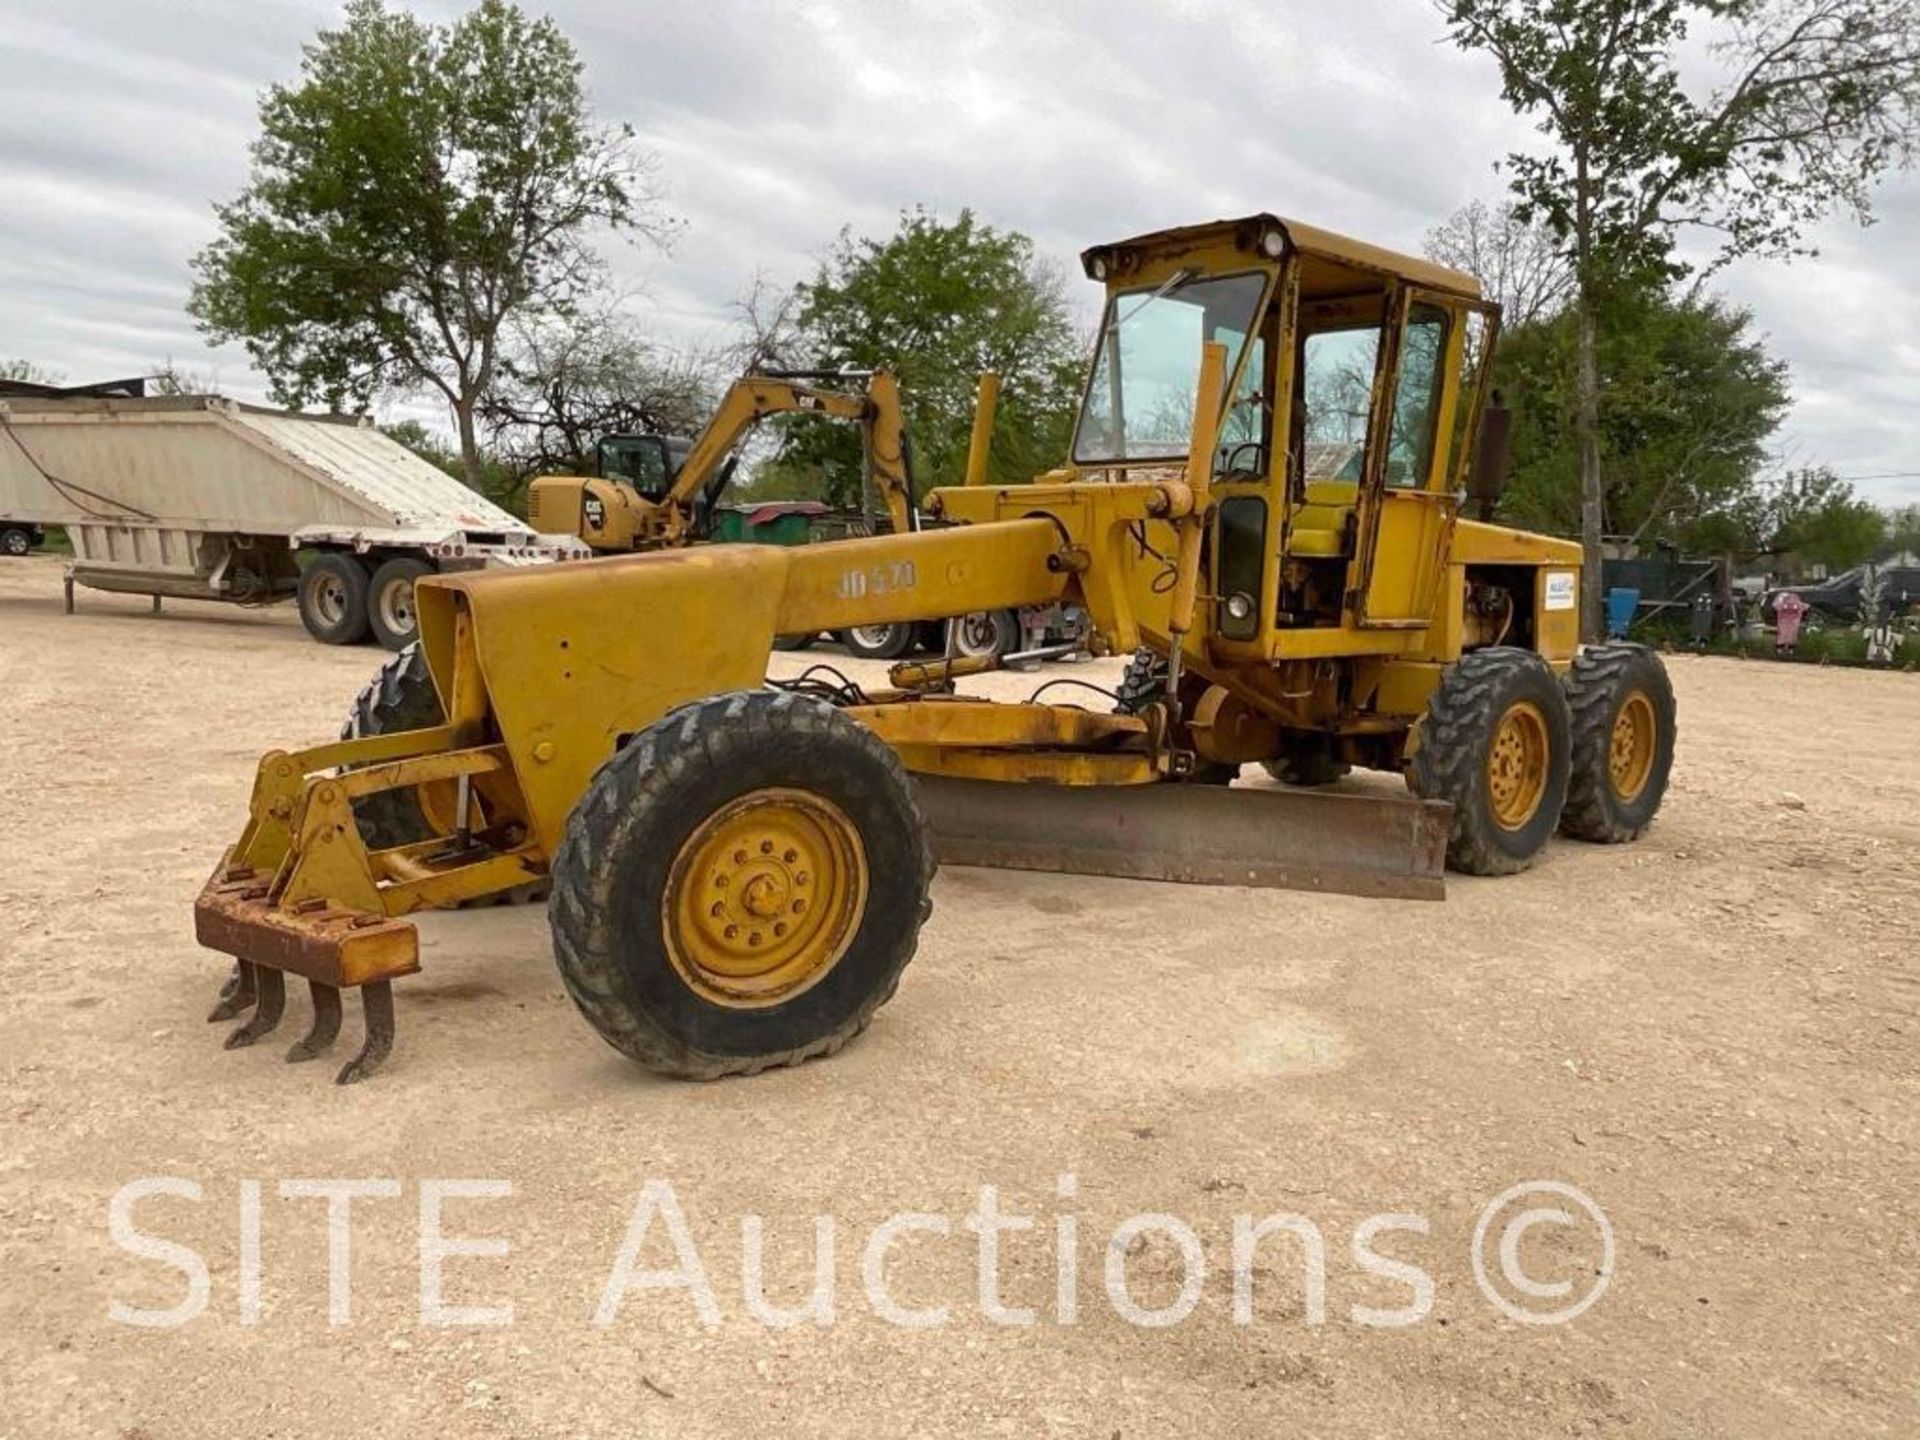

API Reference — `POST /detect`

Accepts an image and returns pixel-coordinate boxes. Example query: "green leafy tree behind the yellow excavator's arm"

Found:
[775,209,1081,503]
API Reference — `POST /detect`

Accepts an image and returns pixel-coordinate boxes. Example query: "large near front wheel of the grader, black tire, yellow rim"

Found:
[547,689,933,1079]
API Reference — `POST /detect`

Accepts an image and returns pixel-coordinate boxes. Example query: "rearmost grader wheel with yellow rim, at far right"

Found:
[1561,645,1676,845]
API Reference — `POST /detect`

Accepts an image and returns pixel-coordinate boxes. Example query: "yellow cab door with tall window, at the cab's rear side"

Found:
[1350,288,1490,630]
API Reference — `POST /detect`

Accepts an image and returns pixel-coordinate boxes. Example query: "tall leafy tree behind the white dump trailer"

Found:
[190,0,662,484]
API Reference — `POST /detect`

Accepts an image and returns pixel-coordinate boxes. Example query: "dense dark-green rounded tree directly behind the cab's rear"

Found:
[1494,288,1788,549]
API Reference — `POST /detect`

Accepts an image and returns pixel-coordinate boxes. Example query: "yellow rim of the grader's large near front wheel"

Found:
[660,789,866,1010]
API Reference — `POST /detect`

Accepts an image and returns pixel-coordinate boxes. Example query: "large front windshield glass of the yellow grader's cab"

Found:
[1073,273,1267,465]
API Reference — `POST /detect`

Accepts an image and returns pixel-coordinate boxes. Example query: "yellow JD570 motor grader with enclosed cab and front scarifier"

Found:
[196,215,1674,1081]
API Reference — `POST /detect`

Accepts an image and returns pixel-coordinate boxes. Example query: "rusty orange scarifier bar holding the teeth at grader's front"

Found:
[194,866,420,987]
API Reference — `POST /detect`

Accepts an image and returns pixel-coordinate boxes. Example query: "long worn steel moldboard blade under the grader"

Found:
[916,776,1453,900]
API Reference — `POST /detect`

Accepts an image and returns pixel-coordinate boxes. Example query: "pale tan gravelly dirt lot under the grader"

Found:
[0,559,1920,1440]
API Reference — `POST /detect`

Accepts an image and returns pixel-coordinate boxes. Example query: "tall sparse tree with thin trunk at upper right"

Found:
[1436,0,1920,639]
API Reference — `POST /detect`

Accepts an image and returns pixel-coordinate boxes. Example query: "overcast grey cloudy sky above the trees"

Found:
[0,0,1920,501]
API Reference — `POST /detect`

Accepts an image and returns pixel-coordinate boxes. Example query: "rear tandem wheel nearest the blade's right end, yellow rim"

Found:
[1407,645,1571,876]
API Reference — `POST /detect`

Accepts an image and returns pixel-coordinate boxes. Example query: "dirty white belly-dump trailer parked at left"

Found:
[0,396,589,649]
